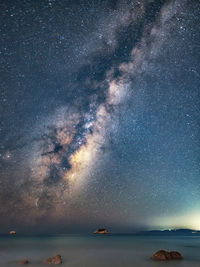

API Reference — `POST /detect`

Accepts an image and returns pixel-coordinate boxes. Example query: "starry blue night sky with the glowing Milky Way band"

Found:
[0,0,200,233]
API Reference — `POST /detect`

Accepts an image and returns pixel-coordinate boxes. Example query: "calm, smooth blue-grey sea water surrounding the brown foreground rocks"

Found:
[0,235,200,267]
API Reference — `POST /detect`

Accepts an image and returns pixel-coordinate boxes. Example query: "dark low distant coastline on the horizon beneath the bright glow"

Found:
[136,229,200,235]
